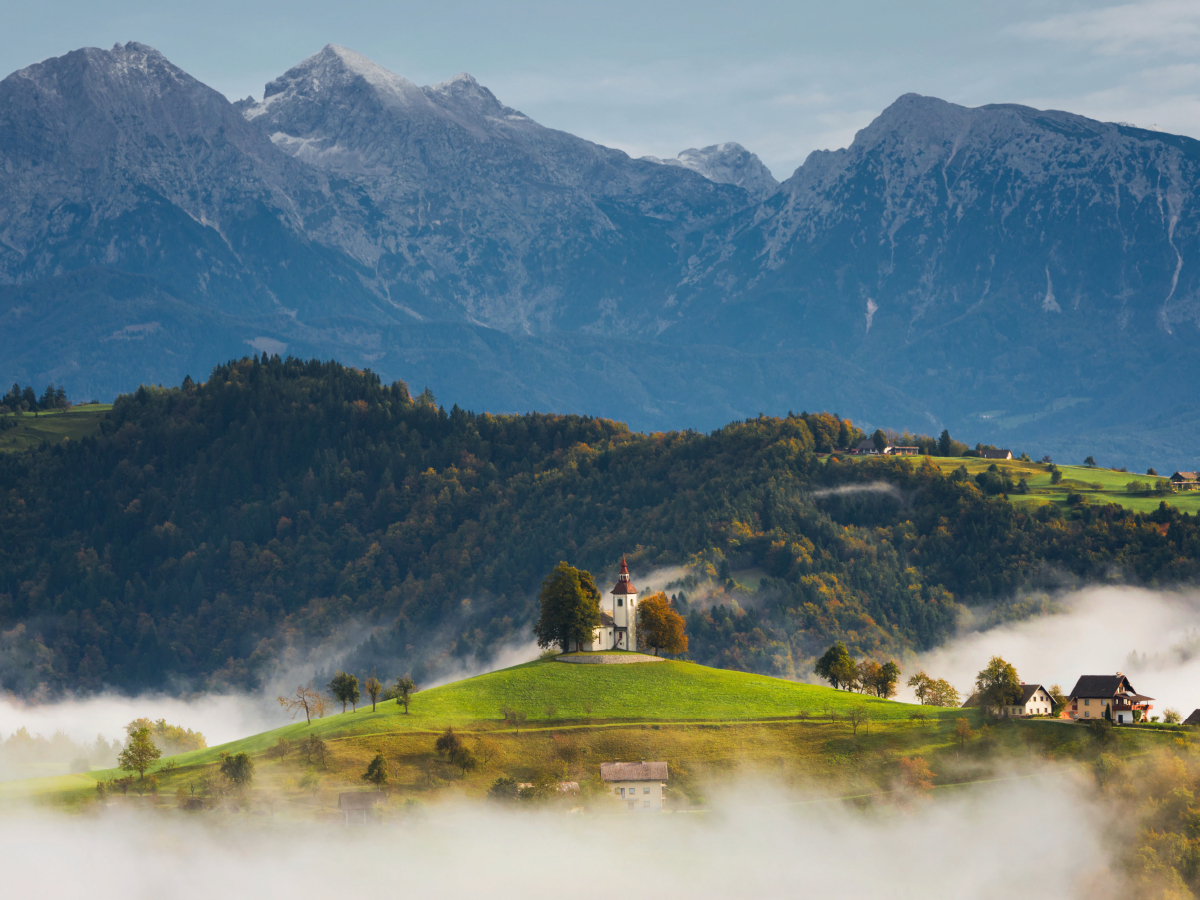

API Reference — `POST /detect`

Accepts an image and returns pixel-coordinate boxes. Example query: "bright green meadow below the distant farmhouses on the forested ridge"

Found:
[842,456,1200,515]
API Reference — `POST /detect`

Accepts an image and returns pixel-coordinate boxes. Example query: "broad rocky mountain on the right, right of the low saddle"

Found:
[678,95,1200,464]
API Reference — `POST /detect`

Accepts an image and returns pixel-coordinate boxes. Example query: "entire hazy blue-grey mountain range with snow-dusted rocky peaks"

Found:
[0,43,1200,467]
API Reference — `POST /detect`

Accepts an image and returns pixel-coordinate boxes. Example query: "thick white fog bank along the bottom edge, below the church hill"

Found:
[0,775,1123,900]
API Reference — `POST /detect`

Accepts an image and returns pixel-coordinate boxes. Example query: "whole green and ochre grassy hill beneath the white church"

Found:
[0,660,1190,817]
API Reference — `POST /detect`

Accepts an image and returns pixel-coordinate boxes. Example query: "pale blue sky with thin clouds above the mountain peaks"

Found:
[0,0,1200,179]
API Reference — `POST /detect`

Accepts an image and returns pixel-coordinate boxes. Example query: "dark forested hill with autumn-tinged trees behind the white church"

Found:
[0,355,1200,692]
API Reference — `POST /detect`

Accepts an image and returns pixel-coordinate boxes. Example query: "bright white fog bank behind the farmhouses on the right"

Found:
[901,587,1200,715]
